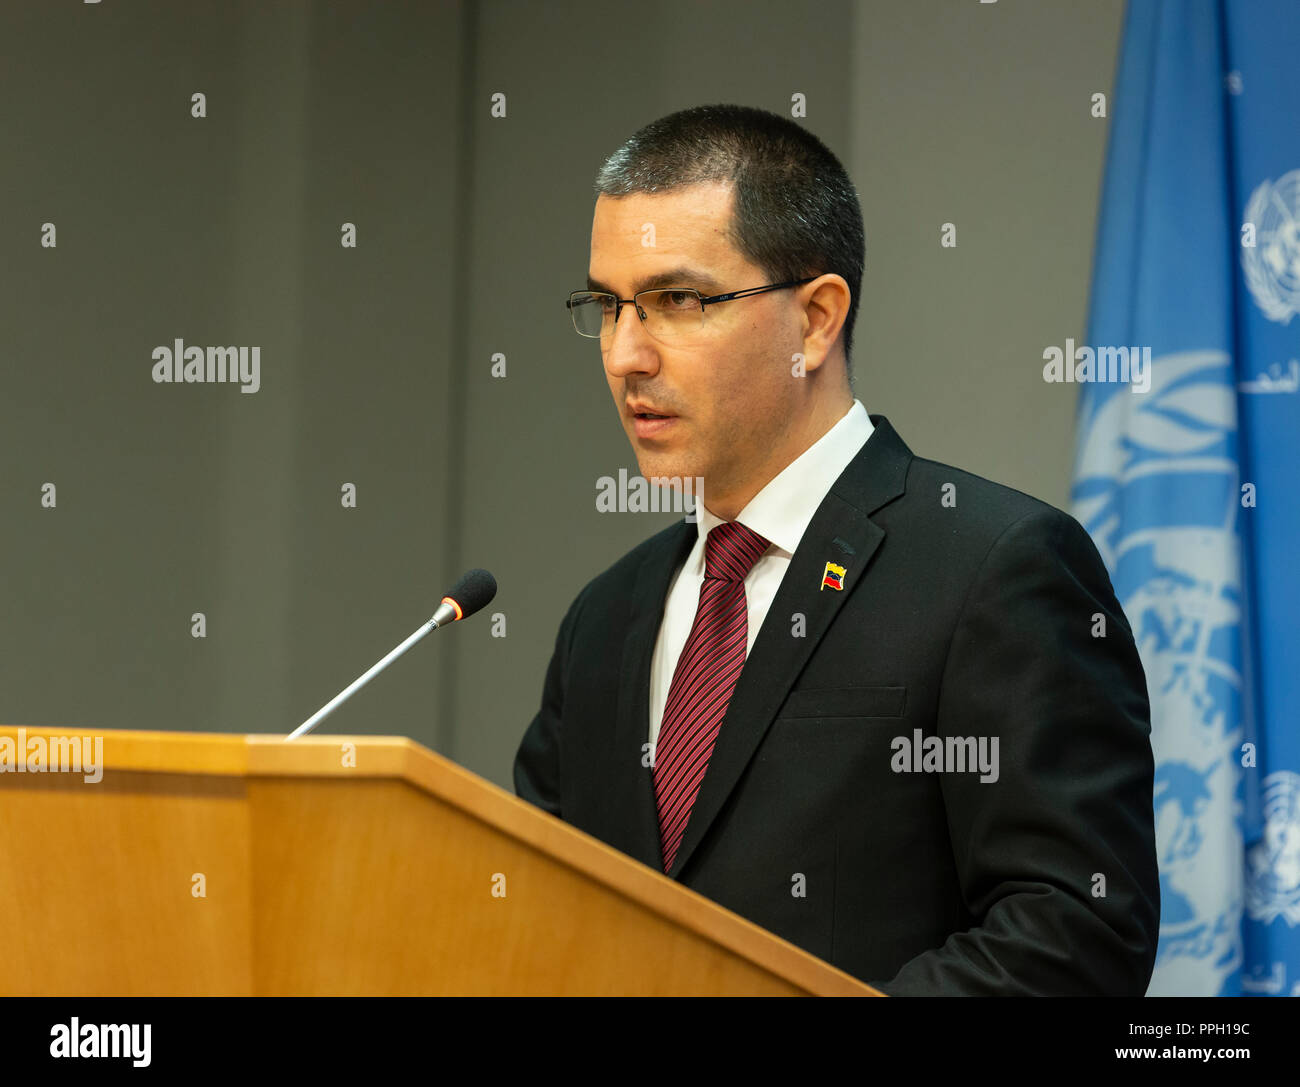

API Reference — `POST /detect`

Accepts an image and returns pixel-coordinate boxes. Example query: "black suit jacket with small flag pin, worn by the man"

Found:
[515,416,1160,995]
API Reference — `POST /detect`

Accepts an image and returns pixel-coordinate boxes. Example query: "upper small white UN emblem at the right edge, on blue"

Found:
[1242,170,1300,325]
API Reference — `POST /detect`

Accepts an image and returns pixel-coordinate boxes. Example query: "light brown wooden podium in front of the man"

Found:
[0,726,880,996]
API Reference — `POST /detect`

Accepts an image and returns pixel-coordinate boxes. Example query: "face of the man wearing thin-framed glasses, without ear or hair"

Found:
[588,182,803,517]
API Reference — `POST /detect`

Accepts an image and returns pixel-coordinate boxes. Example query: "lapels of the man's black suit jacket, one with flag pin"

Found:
[665,415,911,878]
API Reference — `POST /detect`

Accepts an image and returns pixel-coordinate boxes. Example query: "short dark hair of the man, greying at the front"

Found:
[595,105,866,377]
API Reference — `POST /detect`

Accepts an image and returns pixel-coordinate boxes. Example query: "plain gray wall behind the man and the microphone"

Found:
[0,0,1122,784]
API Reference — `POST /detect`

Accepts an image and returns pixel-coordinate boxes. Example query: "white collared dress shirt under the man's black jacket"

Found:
[650,400,875,750]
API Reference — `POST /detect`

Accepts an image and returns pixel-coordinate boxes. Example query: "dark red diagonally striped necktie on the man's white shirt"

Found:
[654,521,768,872]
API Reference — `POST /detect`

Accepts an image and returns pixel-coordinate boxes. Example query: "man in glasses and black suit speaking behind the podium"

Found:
[515,107,1158,995]
